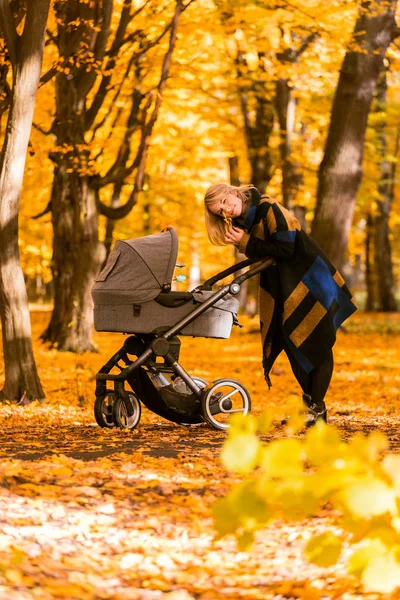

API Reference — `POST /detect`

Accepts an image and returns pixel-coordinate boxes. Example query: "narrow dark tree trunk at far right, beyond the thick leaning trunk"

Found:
[374,71,399,312]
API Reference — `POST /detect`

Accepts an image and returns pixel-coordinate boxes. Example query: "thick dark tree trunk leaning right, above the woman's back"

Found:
[311,0,397,269]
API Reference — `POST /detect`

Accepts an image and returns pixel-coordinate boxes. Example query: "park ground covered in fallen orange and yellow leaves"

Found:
[0,311,400,600]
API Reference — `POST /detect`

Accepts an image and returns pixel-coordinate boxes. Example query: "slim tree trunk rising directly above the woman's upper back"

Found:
[276,79,302,209]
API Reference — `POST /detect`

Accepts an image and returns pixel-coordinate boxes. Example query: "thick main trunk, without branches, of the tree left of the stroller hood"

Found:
[42,37,104,352]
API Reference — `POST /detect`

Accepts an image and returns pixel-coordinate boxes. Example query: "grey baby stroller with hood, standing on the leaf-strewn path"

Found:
[92,228,272,429]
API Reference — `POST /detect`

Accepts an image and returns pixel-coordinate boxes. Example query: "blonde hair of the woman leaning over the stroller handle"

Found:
[204,183,254,246]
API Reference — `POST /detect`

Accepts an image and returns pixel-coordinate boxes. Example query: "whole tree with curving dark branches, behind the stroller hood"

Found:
[41,0,187,352]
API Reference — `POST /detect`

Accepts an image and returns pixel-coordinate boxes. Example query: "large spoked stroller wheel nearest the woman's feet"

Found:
[201,379,251,429]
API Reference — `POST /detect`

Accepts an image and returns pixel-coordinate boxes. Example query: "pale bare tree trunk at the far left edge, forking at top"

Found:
[0,0,50,400]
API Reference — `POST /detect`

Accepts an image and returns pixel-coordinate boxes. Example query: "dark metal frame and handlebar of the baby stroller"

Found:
[95,258,274,429]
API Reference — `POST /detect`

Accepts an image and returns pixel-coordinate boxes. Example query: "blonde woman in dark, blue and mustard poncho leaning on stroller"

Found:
[204,183,356,426]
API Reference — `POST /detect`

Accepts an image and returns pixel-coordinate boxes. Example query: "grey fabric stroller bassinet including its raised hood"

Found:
[92,229,239,339]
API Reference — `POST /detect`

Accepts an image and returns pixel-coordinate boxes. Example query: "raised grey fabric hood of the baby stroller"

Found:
[92,228,178,304]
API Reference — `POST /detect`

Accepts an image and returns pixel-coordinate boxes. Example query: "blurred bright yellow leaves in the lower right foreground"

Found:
[215,417,400,593]
